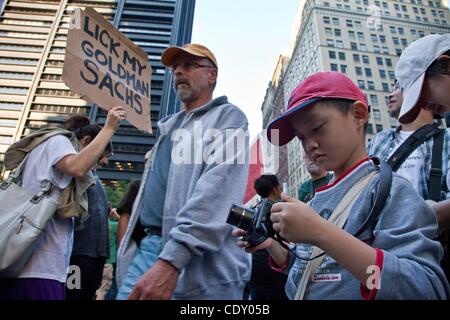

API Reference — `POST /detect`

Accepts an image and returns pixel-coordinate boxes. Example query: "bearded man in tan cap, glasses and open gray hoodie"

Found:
[117,44,251,300]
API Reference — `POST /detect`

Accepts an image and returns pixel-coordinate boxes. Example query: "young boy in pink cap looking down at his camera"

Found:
[235,72,449,299]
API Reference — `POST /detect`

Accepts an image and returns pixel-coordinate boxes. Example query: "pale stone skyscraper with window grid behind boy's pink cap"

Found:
[262,0,450,195]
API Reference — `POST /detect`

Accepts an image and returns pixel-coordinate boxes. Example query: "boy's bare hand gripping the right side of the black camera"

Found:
[270,193,326,244]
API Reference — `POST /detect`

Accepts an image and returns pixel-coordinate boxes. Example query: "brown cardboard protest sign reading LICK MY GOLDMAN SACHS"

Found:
[62,8,152,133]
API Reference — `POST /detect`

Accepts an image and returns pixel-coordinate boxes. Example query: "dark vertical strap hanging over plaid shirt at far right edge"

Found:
[428,129,444,202]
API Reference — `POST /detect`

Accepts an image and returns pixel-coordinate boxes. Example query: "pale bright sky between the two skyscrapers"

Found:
[192,0,299,138]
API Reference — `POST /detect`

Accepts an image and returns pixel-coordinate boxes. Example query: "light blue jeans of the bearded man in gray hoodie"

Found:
[116,235,162,300]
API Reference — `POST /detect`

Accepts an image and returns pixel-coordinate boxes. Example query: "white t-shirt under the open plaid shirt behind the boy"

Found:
[389,130,425,192]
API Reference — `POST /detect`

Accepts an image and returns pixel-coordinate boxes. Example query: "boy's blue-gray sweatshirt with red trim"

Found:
[285,161,449,300]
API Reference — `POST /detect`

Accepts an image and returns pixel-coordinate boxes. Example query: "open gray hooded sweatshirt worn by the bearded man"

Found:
[117,96,251,299]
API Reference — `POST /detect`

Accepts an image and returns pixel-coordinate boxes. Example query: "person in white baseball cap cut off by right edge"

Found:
[395,33,450,277]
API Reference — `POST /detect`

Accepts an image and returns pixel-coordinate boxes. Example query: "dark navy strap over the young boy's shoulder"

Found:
[353,158,392,238]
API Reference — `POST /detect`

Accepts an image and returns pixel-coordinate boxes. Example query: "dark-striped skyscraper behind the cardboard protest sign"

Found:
[0,0,195,181]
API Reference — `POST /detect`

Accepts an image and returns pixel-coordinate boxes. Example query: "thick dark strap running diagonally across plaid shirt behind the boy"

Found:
[387,123,441,172]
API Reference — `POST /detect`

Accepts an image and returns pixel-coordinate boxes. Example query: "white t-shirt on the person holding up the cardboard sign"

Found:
[18,135,77,283]
